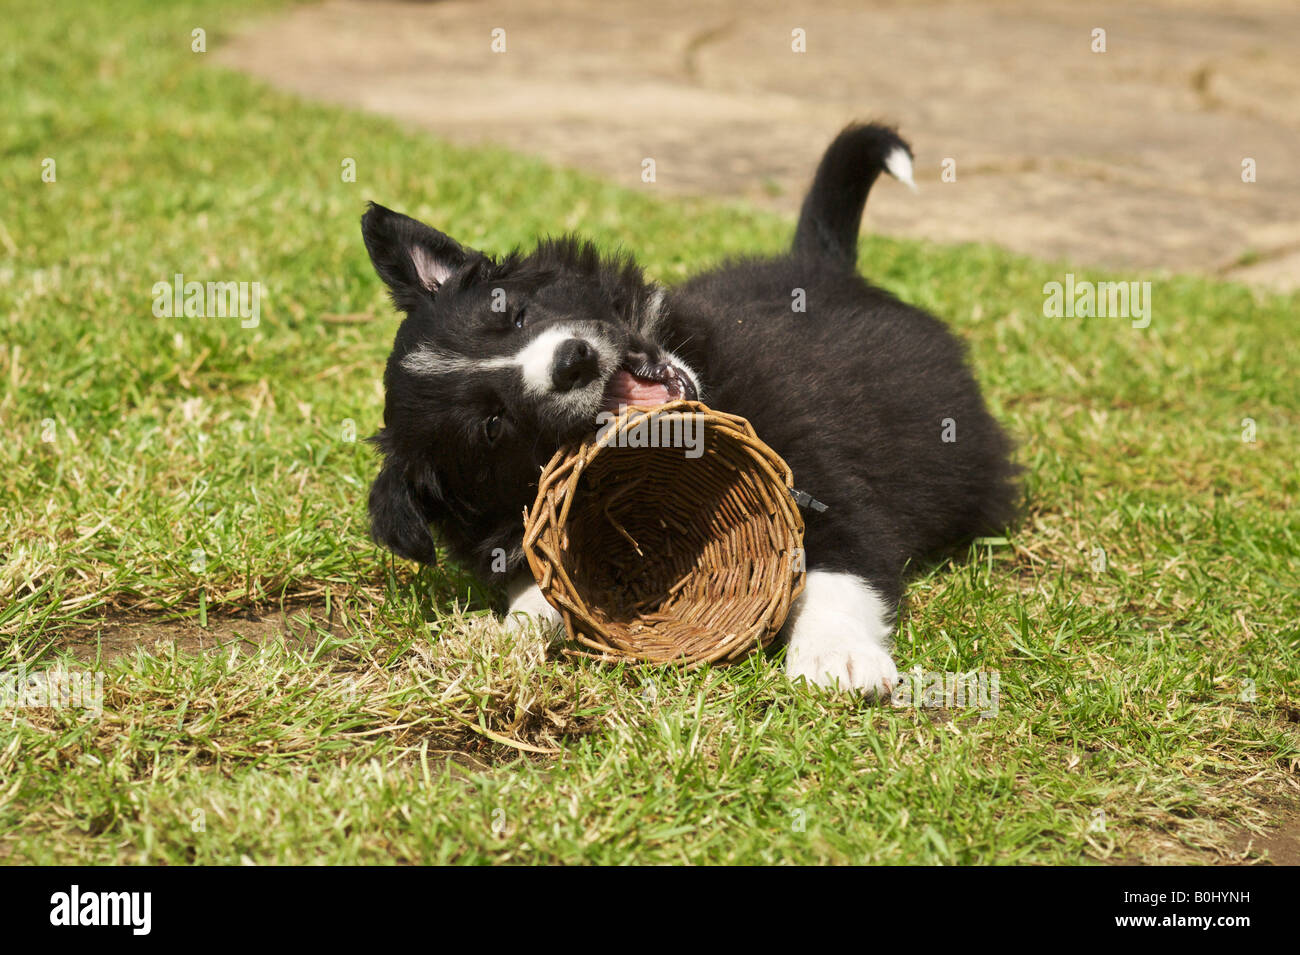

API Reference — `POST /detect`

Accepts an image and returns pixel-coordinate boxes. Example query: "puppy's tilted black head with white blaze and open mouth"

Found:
[361,205,698,573]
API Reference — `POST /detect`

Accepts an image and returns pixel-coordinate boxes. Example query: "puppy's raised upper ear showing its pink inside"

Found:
[361,203,469,312]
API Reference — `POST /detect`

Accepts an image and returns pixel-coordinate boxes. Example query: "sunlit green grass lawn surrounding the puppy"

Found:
[0,0,1300,863]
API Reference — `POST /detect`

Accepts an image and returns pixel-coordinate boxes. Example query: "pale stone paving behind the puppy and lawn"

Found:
[217,0,1300,288]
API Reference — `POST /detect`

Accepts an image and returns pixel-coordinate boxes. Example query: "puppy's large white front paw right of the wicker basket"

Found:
[785,570,898,696]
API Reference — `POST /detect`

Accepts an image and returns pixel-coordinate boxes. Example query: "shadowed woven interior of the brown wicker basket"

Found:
[564,447,780,659]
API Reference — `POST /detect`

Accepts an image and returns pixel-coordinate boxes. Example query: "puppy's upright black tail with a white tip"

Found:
[793,123,917,269]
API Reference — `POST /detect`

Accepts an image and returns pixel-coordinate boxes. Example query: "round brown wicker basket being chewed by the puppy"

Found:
[524,401,803,663]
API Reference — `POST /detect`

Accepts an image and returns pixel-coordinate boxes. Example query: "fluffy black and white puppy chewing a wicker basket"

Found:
[361,125,1017,693]
